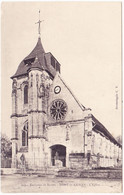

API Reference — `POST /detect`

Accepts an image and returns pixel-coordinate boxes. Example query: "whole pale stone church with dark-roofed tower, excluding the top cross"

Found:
[11,27,121,169]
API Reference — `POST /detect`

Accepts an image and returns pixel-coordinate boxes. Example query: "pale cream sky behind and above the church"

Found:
[1,2,122,137]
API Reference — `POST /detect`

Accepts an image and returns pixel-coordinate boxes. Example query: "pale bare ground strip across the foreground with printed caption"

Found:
[1,175,122,193]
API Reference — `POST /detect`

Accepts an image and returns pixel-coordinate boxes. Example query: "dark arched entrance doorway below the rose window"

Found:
[50,145,66,167]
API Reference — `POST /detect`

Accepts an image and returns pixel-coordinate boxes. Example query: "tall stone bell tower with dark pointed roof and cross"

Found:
[11,14,60,168]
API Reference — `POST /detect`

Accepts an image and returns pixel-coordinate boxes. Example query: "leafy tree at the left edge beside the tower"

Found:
[1,134,12,159]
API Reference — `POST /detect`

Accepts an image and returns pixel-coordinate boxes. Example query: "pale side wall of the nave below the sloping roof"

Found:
[91,131,121,167]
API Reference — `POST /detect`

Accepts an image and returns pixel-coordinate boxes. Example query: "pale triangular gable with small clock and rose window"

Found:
[48,73,85,123]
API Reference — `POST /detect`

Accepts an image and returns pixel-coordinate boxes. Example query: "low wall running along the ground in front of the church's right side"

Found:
[58,170,122,179]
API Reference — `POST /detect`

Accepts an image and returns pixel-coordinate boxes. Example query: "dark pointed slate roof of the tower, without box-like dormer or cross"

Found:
[11,38,56,79]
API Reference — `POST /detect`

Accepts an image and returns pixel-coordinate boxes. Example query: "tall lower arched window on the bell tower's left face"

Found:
[22,122,28,146]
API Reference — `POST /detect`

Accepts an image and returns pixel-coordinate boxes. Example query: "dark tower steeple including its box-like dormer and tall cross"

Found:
[11,11,60,79]
